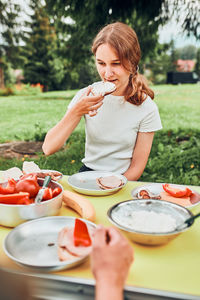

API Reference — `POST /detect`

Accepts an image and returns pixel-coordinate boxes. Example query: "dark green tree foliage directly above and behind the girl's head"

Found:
[46,0,162,63]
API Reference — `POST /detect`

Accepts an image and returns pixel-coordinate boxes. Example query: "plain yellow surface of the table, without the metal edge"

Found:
[0,176,200,297]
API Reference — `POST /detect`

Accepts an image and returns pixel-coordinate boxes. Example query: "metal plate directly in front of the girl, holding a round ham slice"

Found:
[68,171,127,196]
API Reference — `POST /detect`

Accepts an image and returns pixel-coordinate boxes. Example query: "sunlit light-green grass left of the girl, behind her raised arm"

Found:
[0,91,79,143]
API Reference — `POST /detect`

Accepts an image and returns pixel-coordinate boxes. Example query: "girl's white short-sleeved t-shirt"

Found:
[68,89,162,174]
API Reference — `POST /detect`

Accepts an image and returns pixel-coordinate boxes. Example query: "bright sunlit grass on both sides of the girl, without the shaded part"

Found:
[0,84,200,143]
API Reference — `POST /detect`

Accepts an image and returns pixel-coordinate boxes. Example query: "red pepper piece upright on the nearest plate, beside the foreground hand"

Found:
[74,219,92,247]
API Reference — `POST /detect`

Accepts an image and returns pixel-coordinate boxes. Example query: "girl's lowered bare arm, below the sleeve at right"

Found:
[123,132,154,180]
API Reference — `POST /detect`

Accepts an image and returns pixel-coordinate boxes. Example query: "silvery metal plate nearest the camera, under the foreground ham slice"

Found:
[3,216,96,271]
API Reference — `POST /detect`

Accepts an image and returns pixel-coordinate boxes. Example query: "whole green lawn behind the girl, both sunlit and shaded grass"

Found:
[0,84,200,185]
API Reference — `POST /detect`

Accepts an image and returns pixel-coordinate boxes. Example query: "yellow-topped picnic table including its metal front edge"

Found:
[0,176,200,300]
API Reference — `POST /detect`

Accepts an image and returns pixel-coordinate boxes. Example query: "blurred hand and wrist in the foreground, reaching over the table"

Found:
[91,226,133,300]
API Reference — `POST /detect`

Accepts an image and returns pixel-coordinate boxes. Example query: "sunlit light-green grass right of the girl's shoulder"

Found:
[153,84,200,129]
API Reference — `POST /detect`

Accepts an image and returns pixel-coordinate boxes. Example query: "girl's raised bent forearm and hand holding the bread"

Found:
[42,88,103,155]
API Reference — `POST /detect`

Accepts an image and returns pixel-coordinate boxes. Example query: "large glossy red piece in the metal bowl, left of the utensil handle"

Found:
[16,178,40,198]
